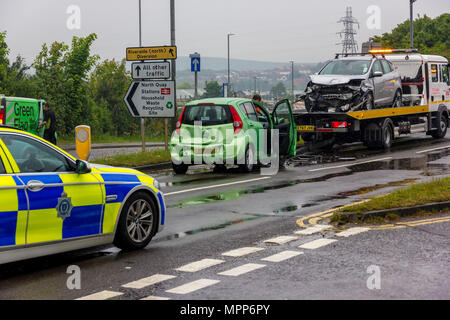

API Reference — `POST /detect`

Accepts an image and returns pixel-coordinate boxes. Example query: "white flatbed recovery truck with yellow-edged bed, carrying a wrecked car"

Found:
[294,52,450,150]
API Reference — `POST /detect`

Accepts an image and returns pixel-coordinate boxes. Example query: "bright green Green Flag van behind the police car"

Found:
[0,96,45,135]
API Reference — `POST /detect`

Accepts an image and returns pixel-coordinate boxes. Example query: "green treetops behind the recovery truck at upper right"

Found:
[375,13,450,59]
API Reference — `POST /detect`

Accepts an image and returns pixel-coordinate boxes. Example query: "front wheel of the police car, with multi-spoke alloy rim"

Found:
[114,192,158,250]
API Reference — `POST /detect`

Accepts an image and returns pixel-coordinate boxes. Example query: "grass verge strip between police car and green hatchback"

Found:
[92,149,171,167]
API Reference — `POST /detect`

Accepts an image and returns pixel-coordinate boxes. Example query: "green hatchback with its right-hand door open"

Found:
[170,98,297,174]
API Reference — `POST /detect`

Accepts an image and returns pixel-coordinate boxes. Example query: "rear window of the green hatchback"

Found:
[181,105,233,126]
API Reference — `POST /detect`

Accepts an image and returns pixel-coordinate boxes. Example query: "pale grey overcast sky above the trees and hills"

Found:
[0,0,450,63]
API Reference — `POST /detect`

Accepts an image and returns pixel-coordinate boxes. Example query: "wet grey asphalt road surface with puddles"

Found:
[0,135,450,300]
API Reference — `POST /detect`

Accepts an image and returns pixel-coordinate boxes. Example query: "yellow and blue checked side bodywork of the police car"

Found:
[0,169,165,247]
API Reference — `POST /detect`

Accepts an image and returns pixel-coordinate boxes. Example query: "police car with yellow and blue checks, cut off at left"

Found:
[0,126,165,264]
